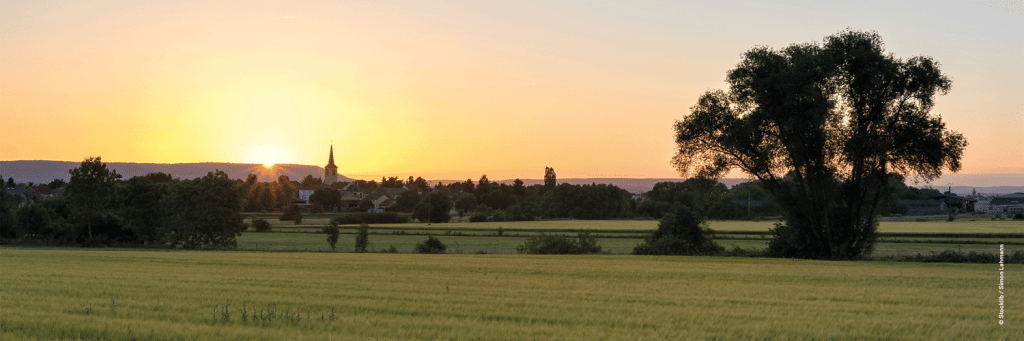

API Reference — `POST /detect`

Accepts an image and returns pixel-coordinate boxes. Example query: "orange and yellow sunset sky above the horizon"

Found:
[0,1,1024,179]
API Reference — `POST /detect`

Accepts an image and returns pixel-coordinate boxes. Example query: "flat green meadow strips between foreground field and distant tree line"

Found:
[238,218,1024,257]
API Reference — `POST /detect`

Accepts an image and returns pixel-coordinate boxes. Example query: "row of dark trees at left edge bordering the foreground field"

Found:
[0,157,246,249]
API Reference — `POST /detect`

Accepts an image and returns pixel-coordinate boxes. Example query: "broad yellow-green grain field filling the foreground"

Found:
[0,248,1024,341]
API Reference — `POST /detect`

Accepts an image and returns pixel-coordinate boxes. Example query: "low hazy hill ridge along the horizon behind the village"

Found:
[0,161,1024,195]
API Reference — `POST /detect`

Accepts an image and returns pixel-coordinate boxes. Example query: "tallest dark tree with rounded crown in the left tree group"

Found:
[68,157,121,239]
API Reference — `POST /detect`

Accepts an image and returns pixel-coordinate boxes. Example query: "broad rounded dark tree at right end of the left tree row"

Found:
[162,171,246,249]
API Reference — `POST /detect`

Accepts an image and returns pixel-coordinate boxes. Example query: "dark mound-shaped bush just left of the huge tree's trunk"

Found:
[633,205,723,255]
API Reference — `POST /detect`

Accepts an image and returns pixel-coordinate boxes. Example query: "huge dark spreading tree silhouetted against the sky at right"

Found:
[673,31,967,259]
